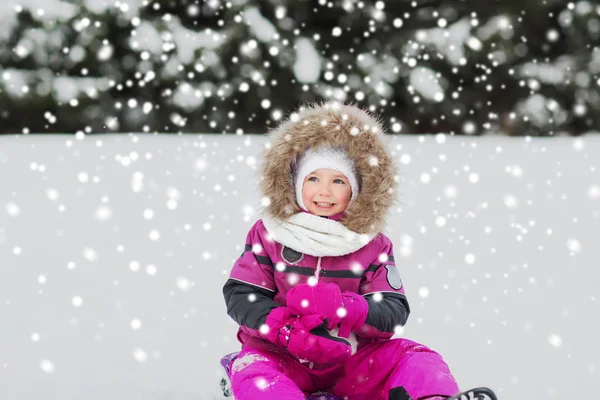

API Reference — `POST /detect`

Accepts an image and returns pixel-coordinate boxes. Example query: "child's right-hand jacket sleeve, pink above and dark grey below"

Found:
[356,235,410,339]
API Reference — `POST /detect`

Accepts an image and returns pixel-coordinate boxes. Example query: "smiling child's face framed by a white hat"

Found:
[302,168,352,216]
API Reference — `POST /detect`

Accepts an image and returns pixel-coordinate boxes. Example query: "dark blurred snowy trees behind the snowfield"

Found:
[0,0,600,136]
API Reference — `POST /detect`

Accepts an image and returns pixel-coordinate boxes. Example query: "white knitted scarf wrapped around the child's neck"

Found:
[262,212,376,257]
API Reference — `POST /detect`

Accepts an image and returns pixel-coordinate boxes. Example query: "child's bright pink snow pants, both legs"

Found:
[231,339,459,400]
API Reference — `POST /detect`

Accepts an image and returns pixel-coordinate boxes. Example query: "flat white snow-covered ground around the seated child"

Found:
[0,135,600,400]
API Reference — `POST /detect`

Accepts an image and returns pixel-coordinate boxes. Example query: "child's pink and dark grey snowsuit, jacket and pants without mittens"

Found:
[223,215,459,400]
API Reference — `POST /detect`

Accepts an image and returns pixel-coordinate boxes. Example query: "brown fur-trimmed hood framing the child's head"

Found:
[260,103,396,238]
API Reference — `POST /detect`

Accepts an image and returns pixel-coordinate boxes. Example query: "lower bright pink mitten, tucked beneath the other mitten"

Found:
[260,307,352,364]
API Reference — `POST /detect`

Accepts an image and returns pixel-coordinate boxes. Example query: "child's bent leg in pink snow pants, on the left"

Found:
[231,347,310,400]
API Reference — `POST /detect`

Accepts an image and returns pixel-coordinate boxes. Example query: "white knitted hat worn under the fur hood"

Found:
[294,147,359,210]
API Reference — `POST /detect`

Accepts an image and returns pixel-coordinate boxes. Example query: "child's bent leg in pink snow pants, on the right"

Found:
[333,339,459,400]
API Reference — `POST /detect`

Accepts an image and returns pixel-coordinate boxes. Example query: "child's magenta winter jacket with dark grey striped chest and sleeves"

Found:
[223,215,410,345]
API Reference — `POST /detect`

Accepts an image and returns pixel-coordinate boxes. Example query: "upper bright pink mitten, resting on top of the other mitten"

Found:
[285,283,343,329]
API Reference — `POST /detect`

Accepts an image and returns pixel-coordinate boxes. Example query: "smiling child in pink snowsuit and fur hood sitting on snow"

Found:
[223,105,495,400]
